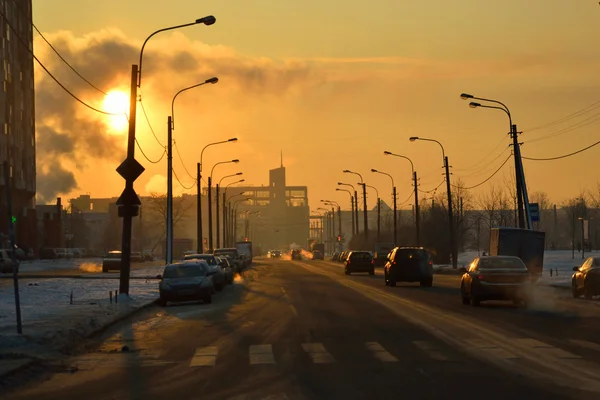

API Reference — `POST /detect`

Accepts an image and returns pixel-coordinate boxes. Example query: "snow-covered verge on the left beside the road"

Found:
[0,265,164,351]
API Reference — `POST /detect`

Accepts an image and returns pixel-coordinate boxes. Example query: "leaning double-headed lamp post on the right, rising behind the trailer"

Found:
[460,93,533,229]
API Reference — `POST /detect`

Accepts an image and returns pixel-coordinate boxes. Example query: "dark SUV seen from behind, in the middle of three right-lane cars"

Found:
[383,247,433,287]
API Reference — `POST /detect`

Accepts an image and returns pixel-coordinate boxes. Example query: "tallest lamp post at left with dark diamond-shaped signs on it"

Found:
[117,15,216,295]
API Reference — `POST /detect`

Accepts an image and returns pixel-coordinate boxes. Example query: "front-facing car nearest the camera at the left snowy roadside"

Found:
[158,260,214,306]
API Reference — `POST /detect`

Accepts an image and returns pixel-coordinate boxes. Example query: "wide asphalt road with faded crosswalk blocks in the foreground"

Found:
[1,260,600,400]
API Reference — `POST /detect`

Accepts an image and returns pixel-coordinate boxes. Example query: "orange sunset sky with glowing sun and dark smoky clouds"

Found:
[33,0,600,209]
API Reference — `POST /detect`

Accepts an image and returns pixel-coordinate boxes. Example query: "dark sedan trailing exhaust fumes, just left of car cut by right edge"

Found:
[460,256,531,306]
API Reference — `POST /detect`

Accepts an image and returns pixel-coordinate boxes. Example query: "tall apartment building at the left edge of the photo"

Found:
[0,0,38,251]
